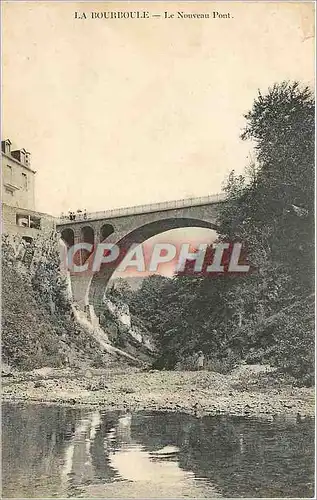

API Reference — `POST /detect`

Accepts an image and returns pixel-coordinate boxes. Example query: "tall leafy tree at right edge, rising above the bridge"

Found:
[217,82,314,379]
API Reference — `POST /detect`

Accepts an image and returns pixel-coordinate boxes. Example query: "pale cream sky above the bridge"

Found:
[2,1,314,215]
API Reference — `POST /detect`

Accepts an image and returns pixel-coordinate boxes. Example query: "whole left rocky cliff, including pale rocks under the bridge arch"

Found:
[2,234,155,369]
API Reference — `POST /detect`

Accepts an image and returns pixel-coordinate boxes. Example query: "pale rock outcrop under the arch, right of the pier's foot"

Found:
[101,296,156,357]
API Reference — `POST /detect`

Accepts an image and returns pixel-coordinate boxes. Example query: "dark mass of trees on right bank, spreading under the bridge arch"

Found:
[126,82,314,384]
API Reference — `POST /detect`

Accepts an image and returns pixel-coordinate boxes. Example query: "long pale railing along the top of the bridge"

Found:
[56,193,226,224]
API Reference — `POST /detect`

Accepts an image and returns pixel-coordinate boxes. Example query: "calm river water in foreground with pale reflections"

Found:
[2,403,314,498]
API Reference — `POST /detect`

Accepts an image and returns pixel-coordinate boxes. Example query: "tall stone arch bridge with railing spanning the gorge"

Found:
[56,194,225,315]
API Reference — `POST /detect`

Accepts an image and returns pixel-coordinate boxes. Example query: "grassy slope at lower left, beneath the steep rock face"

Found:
[2,263,109,369]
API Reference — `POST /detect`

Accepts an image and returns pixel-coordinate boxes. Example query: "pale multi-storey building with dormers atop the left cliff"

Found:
[1,139,55,241]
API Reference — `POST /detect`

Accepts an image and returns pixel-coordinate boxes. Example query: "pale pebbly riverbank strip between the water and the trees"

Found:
[2,366,314,418]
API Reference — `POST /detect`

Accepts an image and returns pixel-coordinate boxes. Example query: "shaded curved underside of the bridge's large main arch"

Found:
[87,217,219,315]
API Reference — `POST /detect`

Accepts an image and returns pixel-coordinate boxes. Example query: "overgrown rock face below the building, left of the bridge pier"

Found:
[2,234,116,369]
